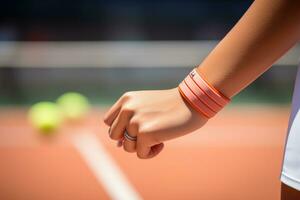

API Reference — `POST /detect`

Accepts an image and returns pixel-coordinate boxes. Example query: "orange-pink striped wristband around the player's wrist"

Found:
[178,69,230,118]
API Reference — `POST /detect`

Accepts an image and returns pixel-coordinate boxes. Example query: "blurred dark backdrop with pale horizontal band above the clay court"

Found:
[0,0,300,105]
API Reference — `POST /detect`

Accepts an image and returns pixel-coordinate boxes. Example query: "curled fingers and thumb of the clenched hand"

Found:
[104,93,164,159]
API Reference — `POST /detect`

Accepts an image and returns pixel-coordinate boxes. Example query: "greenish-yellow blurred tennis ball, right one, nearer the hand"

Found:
[57,92,90,119]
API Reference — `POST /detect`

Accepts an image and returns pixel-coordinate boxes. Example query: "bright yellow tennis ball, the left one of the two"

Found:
[29,102,62,134]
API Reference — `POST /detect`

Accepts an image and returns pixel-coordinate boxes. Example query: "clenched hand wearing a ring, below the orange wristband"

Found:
[104,88,207,159]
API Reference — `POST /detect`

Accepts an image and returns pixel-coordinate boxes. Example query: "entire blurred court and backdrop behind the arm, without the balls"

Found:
[0,0,300,200]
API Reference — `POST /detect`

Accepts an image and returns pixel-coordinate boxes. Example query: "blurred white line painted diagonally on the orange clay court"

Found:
[72,133,142,200]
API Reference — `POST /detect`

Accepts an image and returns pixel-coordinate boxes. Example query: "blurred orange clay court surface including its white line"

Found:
[0,105,289,200]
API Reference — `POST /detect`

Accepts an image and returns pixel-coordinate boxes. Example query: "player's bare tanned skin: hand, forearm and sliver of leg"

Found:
[104,0,300,197]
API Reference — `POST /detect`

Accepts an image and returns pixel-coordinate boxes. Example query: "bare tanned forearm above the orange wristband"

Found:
[197,0,300,97]
